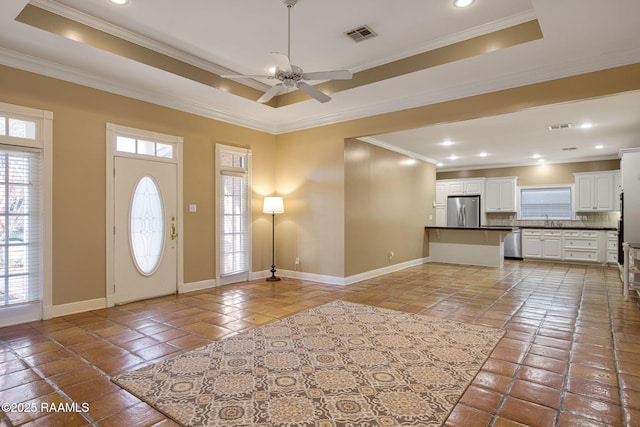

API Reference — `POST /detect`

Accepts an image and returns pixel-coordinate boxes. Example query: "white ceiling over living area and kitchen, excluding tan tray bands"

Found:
[0,0,640,170]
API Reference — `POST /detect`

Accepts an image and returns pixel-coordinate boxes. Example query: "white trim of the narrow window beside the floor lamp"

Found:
[214,144,253,286]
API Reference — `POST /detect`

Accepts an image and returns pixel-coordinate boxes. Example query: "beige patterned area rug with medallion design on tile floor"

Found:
[113,301,504,427]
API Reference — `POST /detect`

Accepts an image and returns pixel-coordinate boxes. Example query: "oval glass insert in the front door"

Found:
[129,176,164,276]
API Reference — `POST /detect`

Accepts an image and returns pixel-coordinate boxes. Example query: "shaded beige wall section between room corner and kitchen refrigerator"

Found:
[344,139,435,276]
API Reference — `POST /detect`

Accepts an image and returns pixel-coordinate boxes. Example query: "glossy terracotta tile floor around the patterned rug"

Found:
[0,261,640,427]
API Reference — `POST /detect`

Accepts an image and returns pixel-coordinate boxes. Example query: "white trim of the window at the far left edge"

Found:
[0,102,53,326]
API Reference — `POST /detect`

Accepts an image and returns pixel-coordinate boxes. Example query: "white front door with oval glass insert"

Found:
[113,156,178,304]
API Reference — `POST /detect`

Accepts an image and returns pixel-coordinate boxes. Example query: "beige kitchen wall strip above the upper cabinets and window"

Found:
[436,159,620,185]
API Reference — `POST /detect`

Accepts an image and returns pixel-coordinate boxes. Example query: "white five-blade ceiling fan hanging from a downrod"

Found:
[220,0,352,102]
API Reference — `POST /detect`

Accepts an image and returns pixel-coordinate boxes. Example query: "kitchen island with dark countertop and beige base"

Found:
[425,226,518,267]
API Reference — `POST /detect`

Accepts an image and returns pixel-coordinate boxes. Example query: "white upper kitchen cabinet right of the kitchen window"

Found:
[573,171,620,212]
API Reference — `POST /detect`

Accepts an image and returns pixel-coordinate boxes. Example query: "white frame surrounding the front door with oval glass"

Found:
[105,123,184,307]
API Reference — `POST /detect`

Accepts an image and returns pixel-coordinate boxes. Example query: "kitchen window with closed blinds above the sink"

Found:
[520,186,573,220]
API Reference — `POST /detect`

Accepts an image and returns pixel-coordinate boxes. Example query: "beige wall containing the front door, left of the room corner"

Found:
[0,67,275,305]
